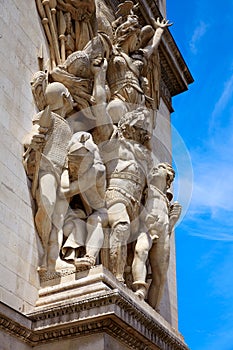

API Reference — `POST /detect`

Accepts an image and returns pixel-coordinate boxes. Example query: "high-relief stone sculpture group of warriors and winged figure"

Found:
[23,0,181,309]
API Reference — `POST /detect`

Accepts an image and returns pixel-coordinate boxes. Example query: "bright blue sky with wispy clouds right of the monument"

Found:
[167,0,233,350]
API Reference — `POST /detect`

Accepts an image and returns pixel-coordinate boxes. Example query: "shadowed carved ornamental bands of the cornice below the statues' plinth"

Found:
[0,292,187,350]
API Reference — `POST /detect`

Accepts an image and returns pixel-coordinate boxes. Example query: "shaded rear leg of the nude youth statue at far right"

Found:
[148,234,170,310]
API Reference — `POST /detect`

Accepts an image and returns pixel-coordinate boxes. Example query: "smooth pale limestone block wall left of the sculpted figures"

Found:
[0,0,47,312]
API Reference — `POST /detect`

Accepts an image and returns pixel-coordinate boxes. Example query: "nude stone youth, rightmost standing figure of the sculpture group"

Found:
[132,163,181,309]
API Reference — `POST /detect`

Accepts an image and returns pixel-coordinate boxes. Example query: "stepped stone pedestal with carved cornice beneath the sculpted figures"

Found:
[1,265,188,350]
